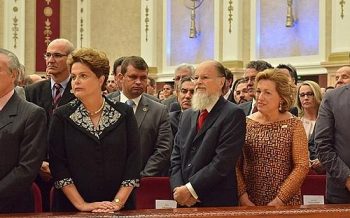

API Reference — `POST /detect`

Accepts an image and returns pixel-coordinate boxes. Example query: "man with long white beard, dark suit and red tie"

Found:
[170,60,246,207]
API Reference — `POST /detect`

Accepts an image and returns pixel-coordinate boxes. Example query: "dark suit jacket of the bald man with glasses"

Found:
[25,80,75,125]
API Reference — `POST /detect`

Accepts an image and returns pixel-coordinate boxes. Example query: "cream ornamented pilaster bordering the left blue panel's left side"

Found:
[141,0,158,77]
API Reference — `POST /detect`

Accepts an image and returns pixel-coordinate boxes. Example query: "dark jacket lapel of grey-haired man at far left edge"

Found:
[0,92,19,130]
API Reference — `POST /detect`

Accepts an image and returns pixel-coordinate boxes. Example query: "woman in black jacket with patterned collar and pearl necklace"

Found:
[49,49,141,212]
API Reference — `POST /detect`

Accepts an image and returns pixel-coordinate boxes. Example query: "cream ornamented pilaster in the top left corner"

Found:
[4,0,25,64]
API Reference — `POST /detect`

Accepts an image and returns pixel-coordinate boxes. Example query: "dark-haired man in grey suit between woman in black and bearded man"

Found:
[108,56,173,177]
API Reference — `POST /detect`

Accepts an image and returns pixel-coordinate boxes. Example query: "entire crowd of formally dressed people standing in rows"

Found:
[0,39,350,213]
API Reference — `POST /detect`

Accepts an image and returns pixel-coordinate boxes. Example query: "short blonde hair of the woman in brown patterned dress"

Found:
[255,68,296,113]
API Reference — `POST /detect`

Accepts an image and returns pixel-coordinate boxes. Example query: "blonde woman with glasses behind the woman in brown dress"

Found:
[297,80,324,173]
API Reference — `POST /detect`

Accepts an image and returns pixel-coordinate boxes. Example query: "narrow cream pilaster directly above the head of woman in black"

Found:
[76,0,91,48]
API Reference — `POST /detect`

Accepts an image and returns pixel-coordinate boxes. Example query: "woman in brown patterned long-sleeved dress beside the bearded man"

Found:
[237,69,309,206]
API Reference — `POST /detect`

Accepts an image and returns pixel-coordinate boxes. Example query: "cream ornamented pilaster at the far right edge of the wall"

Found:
[322,0,350,86]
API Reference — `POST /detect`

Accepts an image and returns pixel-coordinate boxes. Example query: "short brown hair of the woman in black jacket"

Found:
[67,48,110,87]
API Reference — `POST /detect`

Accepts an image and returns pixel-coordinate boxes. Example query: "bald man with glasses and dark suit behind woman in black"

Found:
[25,39,75,211]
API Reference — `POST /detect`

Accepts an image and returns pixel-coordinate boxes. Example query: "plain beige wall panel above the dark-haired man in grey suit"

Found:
[91,0,141,66]
